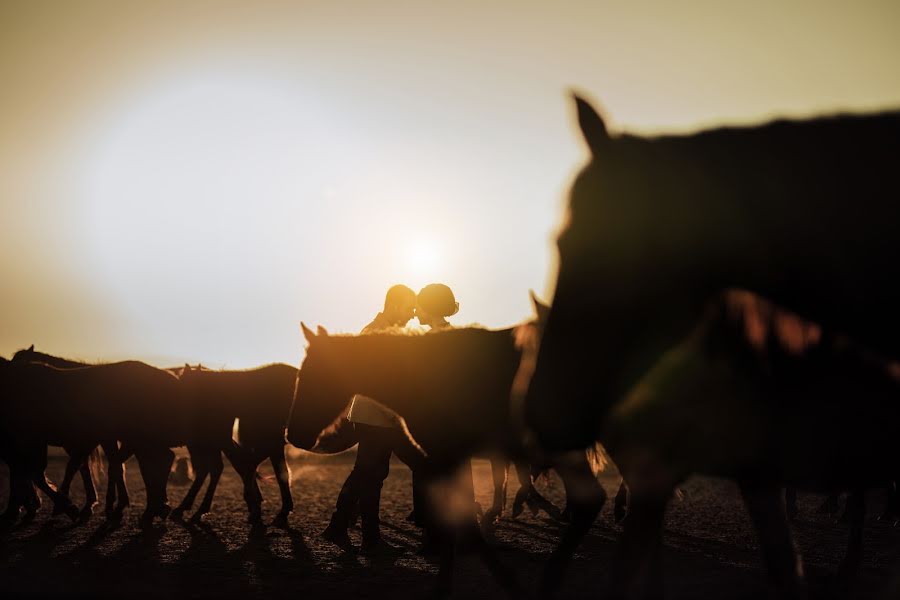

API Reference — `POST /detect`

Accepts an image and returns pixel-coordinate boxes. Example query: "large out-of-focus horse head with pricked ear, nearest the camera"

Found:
[524,96,708,449]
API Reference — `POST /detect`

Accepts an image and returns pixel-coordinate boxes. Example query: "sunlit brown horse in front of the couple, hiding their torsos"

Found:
[288,310,605,591]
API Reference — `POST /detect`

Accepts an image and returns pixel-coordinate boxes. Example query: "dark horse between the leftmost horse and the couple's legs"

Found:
[176,363,297,526]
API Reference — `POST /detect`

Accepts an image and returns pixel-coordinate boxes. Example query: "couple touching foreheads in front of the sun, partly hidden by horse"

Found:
[322,283,459,553]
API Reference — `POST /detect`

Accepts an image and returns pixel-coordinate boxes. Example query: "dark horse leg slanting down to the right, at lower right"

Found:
[739,482,805,598]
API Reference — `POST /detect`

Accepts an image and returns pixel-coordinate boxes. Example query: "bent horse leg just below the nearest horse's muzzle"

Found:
[538,457,606,598]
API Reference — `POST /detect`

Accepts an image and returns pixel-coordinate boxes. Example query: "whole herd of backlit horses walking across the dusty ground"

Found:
[0,97,900,598]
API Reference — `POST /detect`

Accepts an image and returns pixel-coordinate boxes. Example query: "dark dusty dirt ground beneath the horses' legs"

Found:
[0,454,900,599]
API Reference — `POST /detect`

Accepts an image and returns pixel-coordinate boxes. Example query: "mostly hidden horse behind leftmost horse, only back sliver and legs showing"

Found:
[12,344,130,518]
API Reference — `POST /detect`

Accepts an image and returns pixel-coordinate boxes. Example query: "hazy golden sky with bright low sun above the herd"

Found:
[0,0,900,368]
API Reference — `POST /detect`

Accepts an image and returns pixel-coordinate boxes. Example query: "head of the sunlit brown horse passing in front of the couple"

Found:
[287,324,353,450]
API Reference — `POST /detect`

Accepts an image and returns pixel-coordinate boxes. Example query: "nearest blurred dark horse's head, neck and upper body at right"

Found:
[525,97,900,448]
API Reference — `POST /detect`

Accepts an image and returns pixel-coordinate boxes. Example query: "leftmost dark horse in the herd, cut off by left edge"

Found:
[0,361,186,523]
